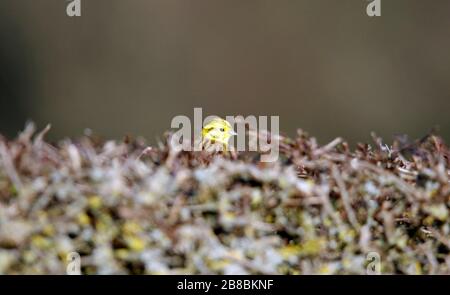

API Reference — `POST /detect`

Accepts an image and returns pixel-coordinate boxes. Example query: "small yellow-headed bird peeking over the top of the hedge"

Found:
[202,117,237,151]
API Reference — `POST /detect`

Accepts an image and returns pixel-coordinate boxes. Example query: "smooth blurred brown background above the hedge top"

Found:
[0,0,450,143]
